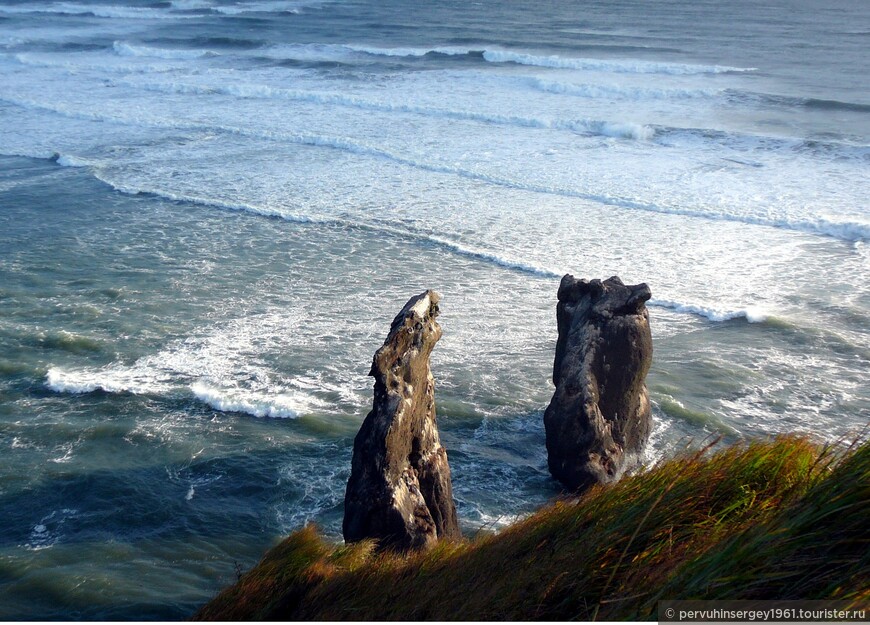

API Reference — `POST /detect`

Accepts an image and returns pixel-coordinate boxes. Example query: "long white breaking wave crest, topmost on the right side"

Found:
[483,50,756,76]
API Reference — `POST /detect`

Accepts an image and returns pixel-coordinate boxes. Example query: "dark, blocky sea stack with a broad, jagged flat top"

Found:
[544,274,652,491]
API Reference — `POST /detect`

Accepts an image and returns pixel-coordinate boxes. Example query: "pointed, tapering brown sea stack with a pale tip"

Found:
[343,291,460,550]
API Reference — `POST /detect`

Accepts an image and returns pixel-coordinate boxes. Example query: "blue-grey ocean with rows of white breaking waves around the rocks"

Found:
[0,0,870,620]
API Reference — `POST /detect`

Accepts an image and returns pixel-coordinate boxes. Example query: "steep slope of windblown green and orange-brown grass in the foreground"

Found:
[195,437,870,620]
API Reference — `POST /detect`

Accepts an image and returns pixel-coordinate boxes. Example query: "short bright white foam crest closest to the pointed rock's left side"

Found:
[190,382,322,419]
